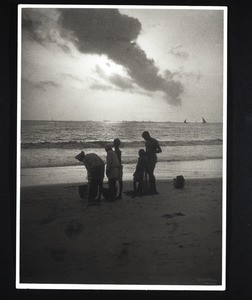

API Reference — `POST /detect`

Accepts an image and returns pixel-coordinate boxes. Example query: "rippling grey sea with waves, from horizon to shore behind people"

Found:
[21,121,223,186]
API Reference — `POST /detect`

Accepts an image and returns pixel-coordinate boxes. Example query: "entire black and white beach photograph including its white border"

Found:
[16,4,228,291]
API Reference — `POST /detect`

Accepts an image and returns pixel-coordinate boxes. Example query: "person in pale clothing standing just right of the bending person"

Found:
[105,144,120,201]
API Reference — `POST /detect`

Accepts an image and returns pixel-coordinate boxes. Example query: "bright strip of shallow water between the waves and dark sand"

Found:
[20,159,222,187]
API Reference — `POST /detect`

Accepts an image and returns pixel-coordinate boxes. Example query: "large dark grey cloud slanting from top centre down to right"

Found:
[59,9,183,105]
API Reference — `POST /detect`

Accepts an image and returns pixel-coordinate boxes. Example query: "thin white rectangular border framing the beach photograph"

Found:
[16,4,228,291]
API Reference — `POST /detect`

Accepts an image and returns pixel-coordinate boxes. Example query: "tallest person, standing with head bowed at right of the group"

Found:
[142,131,162,194]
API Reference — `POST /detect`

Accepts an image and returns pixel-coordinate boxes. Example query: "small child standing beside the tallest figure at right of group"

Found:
[132,149,147,197]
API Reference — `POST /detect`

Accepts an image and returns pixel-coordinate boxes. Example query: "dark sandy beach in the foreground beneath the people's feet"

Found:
[20,178,222,286]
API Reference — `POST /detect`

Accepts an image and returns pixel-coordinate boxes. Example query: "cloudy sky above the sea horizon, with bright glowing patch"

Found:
[20,7,224,122]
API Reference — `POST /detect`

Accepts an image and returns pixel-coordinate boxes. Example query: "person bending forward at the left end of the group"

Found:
[75,151,104,201]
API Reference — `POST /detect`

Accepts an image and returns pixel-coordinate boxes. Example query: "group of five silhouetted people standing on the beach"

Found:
[75,131,162,202]
